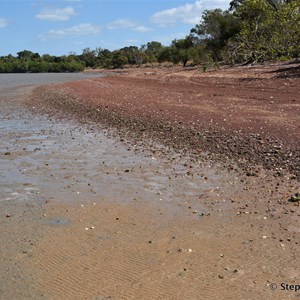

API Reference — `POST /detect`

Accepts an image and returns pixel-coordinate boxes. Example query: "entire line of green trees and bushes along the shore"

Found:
[0,0,300,73]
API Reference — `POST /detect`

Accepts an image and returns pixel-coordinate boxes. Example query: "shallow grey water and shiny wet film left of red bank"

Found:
[0,74,220,216]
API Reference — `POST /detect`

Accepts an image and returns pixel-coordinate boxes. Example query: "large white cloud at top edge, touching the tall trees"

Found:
[151,0,229,26]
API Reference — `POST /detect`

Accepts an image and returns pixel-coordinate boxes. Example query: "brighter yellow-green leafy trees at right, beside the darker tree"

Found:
[223,0,300,63]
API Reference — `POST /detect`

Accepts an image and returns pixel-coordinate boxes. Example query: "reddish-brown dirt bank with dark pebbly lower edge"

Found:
[29,64,300,178]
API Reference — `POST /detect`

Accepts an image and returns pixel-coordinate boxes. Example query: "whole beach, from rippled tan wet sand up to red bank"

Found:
[0,63,300,300]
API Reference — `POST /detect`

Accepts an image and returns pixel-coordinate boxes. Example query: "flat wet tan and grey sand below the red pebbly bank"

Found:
[0,68,300,299]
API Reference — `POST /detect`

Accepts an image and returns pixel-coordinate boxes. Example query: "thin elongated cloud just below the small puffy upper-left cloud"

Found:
[38,23,101,41]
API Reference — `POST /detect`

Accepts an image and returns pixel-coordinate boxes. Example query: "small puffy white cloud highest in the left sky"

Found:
[35,6,77,21]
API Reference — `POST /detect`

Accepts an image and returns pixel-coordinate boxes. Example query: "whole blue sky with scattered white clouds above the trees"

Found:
[0,0,230,56]
